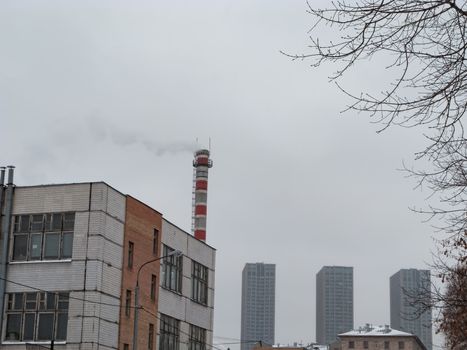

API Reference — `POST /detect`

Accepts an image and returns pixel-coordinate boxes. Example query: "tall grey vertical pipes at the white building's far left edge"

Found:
[0,165,15,338]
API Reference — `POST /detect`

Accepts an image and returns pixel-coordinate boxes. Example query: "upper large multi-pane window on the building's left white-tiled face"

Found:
[12,213,75,261]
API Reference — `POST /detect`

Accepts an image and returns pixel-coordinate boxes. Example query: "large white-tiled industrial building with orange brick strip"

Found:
[0,174,215,350]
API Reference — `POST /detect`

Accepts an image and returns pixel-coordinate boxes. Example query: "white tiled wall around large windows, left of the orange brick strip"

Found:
[2,183,126,350]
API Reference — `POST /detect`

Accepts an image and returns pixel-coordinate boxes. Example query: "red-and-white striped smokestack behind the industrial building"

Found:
[193,149,212,242]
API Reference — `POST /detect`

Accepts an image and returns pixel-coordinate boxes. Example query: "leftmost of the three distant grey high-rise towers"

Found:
[240,263,276,350]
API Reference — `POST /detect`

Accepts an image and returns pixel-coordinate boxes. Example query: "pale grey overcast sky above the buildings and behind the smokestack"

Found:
[0,0,440,343]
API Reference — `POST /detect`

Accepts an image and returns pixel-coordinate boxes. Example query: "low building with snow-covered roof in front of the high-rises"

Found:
[336,325,426,350]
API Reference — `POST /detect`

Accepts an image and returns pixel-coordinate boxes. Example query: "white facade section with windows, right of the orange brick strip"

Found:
[159,219,215,350]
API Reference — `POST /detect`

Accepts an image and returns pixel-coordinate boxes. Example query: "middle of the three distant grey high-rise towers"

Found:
[316,266,353,344]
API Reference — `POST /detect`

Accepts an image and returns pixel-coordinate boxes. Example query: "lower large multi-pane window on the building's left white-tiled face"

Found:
[5,292,69,341]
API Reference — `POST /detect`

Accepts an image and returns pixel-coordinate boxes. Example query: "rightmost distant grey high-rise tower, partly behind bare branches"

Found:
[390,269,433,350]
